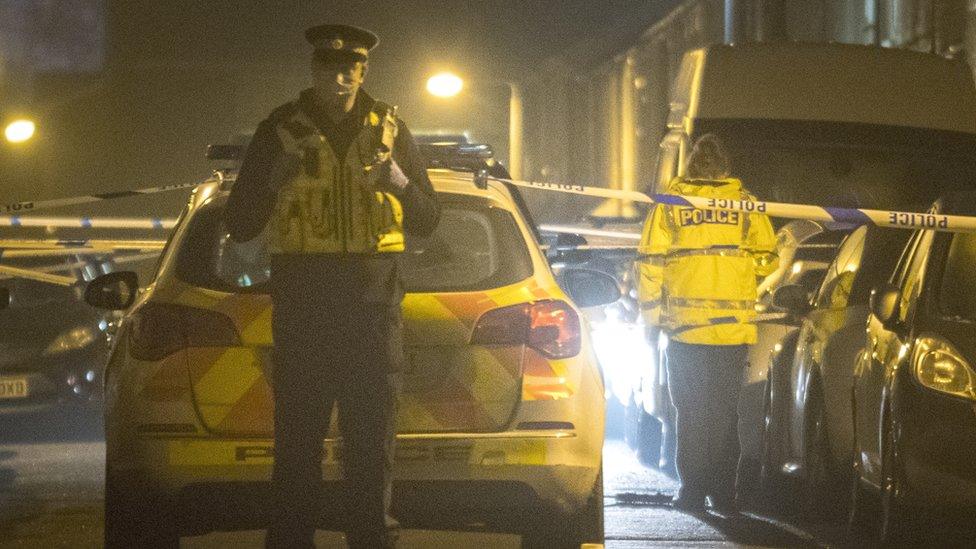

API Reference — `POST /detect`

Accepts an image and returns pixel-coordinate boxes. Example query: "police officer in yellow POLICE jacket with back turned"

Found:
[638,134,777,513]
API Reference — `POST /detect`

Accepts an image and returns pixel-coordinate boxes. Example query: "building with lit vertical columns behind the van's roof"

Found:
[524,0,976,223]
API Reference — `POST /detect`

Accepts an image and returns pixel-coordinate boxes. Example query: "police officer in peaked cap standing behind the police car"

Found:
[225,25,440,548]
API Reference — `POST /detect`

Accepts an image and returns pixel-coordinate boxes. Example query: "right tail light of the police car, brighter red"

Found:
[471,300,580,358]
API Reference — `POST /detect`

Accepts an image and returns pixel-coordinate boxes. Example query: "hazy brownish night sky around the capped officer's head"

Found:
[0,0,673,213]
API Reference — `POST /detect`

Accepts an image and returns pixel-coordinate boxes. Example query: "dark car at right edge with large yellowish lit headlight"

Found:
[851,192,976,545]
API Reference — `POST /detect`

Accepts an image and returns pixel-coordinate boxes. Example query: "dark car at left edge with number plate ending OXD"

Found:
[0,278,111,414]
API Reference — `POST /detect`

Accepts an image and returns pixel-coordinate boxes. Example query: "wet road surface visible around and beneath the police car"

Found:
[0,407,836,549]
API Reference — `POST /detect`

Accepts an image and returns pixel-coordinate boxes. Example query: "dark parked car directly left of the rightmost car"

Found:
[762,226,910,512]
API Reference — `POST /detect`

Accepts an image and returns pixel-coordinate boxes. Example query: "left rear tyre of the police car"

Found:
[104,467,180,549]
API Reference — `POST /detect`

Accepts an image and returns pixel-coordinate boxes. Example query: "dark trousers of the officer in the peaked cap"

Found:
[266,258,403,548]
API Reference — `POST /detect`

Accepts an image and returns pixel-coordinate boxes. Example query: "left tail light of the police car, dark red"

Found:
[129,303,240,361]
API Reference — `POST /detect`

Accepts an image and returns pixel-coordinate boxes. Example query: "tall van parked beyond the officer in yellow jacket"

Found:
[631,42,976,480]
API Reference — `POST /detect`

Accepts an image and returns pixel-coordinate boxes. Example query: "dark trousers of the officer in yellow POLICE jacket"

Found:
[667,340,748,502]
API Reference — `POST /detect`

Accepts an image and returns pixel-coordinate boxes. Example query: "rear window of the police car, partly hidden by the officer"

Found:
[176,195,532,293]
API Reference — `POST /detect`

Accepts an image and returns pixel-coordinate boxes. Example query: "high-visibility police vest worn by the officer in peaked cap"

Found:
[269,103,404,254]
